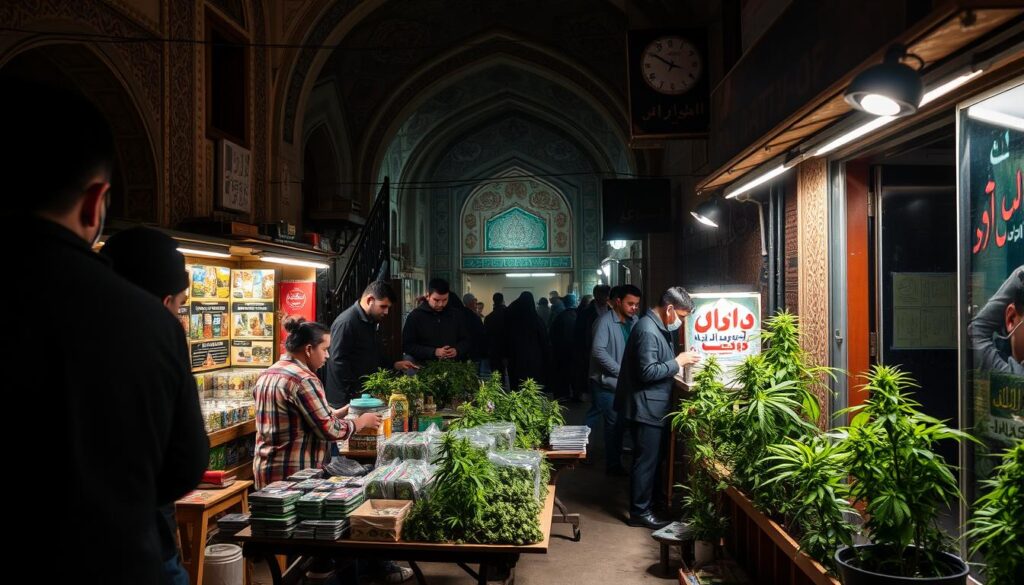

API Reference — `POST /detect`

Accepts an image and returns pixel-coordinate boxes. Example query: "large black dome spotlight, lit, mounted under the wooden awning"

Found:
[845,45,925,118]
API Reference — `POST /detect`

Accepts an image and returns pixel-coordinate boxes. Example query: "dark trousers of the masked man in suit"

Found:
[630,421,669,516]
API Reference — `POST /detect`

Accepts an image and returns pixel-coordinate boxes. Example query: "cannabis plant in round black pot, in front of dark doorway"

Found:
[836,366,968,585]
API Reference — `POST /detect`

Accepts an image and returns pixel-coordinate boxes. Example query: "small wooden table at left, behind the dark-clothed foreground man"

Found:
[174,480,253,585]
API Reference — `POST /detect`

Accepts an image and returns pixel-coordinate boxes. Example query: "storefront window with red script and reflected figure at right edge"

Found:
[958,80,1024,557]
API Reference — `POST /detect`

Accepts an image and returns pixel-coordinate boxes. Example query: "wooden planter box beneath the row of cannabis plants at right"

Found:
[724,486,840,585]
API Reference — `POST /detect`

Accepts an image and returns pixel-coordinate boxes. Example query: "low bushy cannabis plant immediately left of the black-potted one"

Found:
[764,434,857,570]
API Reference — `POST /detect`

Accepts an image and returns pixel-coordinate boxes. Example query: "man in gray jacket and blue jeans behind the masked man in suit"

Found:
[587,285,640,475]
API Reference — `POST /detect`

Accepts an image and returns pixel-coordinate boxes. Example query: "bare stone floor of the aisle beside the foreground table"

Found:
[254,404,678,585]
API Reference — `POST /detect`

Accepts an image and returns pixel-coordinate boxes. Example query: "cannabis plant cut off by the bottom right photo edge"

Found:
[964,441,1024,585]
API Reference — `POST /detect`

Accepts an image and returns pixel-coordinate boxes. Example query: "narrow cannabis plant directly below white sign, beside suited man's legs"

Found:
[670,357,730,568]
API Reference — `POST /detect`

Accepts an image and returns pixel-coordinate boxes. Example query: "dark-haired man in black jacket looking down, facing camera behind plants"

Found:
[401,279,470,362]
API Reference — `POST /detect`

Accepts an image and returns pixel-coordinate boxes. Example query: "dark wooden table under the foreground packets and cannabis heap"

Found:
[234,487,555,585]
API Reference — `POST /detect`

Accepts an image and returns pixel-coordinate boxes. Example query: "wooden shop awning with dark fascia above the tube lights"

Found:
[696,0,1024,193]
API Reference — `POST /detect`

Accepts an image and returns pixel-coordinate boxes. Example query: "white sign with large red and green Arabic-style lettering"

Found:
[686,292,761,382]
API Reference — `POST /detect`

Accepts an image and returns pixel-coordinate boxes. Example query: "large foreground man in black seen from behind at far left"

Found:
[0,79,209,585]
